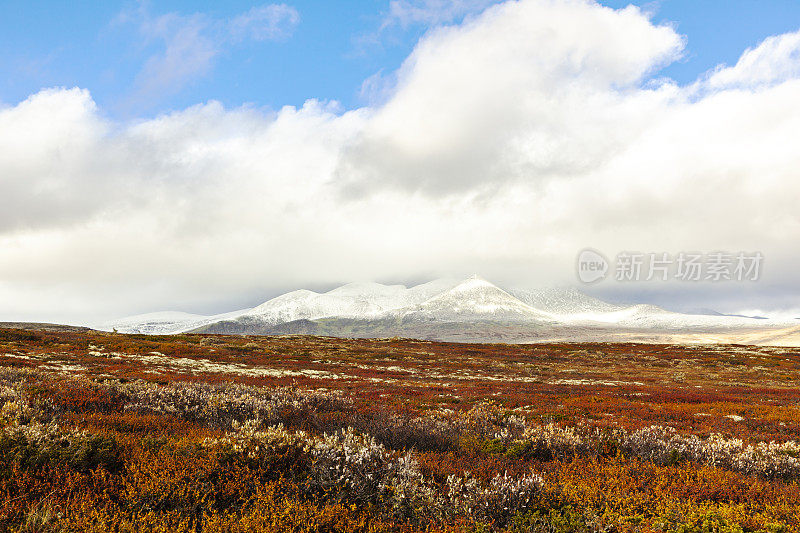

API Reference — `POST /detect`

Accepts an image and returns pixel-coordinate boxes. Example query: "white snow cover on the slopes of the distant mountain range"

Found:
[101,276,796,334]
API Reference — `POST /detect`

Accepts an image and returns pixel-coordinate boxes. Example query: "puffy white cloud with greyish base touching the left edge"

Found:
[0,89,109,232]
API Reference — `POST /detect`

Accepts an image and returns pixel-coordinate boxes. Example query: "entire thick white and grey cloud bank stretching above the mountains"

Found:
[0,0,800,322]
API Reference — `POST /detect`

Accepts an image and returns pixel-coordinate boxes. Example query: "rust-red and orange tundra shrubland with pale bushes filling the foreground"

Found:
[0,329,800,533]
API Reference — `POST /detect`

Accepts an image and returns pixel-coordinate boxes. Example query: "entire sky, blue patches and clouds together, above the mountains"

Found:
[0,0,800,323]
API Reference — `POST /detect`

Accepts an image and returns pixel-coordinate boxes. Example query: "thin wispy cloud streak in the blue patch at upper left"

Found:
[122,4,300,103]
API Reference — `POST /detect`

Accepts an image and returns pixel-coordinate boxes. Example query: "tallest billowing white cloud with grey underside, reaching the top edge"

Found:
[339,1,683,193]
